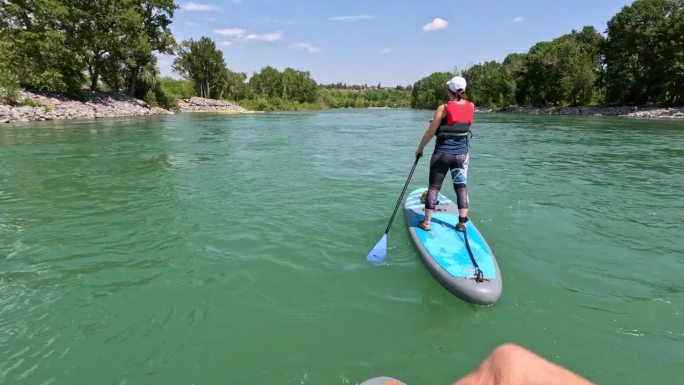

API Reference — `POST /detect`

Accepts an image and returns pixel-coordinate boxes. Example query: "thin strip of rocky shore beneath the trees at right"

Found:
[483,106,684,119]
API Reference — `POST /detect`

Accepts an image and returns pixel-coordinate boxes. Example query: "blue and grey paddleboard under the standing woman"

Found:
[404,188,503,305]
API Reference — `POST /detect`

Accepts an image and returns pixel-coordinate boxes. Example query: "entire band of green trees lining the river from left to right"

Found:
[0,0,684,110]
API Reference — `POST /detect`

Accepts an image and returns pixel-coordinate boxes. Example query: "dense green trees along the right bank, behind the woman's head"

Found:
[411,0,684,108]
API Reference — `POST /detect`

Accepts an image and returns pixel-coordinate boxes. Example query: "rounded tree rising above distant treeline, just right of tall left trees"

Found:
[172,36,227,98]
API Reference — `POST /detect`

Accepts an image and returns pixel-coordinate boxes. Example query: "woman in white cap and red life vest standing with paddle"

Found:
[416,76,475,231]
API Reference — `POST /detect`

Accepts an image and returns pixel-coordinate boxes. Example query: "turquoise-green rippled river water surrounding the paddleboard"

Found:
[0,110,684,385]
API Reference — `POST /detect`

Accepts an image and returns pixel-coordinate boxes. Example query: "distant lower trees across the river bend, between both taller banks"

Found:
[162,36,410,111]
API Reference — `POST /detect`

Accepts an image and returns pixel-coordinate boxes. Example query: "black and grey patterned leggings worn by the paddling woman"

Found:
[425,151,470,210]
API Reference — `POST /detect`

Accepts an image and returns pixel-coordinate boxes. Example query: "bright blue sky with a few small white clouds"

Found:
[159,0,632,86]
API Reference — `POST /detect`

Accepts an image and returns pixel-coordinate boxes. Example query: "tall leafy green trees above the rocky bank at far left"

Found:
[0,0,177,105]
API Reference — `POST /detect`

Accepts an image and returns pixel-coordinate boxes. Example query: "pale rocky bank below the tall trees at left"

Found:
[0,90,173,124]
